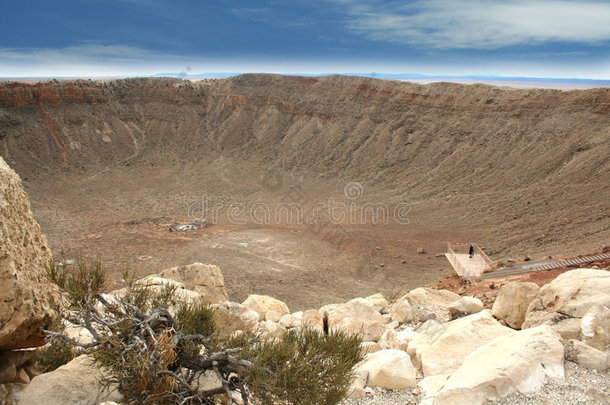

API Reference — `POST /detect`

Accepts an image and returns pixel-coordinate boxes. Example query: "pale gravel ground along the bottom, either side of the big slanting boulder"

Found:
[341,361,610,405]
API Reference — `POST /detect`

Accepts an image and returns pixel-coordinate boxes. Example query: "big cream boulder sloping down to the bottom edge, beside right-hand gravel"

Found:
[422,325,564,405]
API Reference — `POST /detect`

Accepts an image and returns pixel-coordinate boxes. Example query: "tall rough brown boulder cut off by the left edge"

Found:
[0,157,60,350]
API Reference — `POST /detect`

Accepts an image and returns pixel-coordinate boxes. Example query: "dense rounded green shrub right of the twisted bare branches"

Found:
[236,328,362,405]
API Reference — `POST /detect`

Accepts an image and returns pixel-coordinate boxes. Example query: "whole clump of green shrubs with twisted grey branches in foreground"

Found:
[39,260,361,404]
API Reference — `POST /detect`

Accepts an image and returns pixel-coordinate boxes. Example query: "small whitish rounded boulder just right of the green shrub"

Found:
[358,349,417,389]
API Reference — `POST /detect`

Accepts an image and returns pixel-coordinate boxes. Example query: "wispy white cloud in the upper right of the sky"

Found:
[331,0,610,49]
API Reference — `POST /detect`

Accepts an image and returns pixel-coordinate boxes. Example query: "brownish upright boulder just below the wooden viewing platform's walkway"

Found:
[491,282,540,329]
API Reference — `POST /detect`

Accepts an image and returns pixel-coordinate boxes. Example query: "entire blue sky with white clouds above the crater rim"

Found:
[0,0,610,79]
